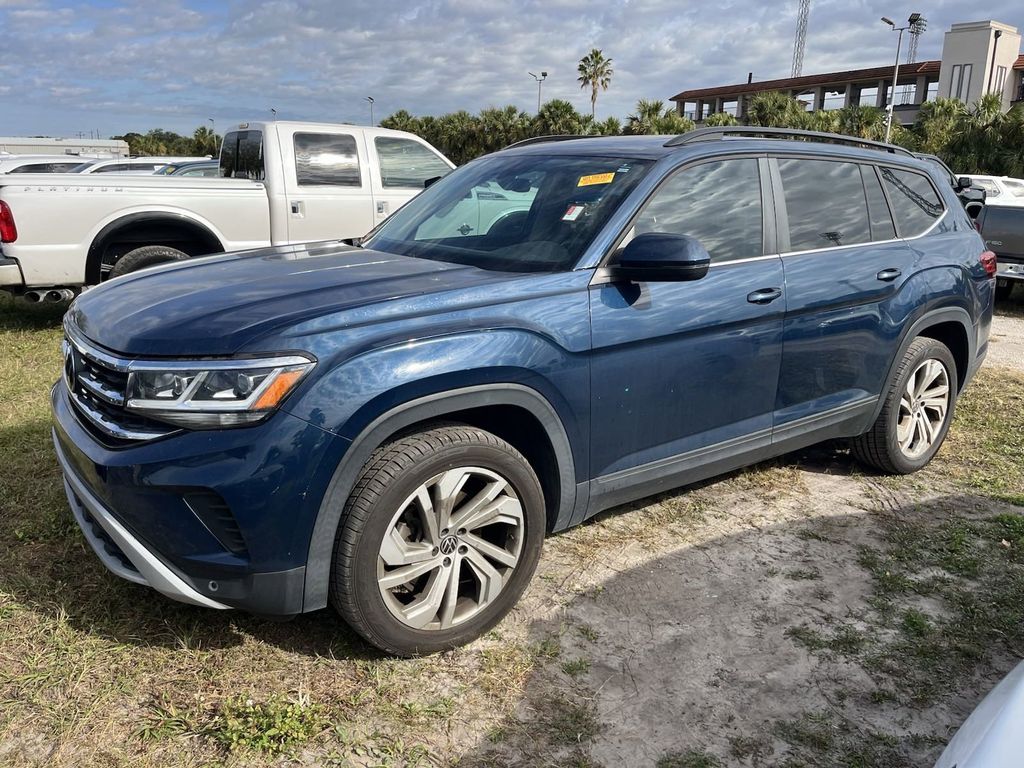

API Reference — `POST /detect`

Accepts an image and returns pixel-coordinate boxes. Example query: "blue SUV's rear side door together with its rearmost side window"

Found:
[772,157,943,442]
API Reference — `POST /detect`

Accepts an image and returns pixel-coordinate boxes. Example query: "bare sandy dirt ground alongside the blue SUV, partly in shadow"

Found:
[456,316,1024,766]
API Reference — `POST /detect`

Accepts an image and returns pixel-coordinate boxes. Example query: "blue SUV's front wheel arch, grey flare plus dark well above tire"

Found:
[303,383,577,611]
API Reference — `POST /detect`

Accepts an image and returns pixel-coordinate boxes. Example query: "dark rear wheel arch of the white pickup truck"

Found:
[85,211,224,285]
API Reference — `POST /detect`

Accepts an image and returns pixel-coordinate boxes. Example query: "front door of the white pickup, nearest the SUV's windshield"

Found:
[364,133,452,230]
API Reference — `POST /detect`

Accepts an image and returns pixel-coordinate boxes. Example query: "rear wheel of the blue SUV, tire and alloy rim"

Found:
[853,337,957,475]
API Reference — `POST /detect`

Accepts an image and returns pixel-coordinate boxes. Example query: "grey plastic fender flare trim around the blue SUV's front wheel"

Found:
[302,384,577,612]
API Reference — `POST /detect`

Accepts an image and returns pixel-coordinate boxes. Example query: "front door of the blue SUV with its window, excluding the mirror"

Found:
[590,157,785,508]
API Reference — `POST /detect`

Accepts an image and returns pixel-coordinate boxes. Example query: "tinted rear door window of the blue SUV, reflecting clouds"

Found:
[778,158,871,251]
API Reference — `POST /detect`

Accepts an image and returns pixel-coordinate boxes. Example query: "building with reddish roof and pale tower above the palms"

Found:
[672,22,1024,125]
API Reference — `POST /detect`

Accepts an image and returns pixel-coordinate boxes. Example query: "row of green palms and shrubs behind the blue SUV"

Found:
[380,90,1024,176]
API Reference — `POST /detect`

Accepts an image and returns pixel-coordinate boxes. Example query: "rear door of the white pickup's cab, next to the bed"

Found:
[279,126,374,243]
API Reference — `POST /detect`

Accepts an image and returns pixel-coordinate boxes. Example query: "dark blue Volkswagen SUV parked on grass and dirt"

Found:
[52,128,995,654]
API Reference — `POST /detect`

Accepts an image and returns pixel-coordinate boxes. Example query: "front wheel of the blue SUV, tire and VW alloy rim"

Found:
[331,425,547,656]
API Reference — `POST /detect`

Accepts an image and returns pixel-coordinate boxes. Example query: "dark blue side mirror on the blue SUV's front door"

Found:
[612,232,711,283]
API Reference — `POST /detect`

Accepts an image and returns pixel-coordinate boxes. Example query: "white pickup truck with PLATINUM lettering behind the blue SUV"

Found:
[0,121,453,301]
